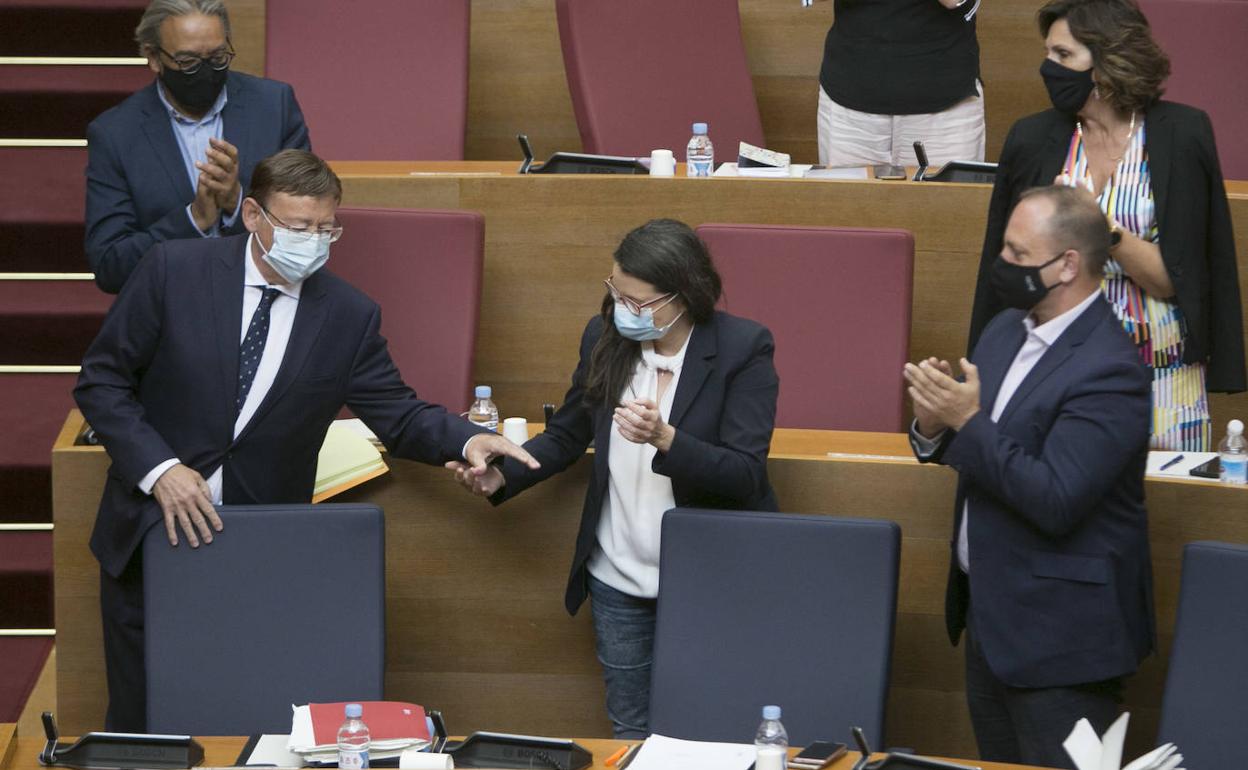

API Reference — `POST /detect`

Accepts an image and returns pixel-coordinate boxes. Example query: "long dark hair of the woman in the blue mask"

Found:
[585,220,723,407]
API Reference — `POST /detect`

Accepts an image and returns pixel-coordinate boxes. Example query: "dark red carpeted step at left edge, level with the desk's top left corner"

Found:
[0,373,77,522]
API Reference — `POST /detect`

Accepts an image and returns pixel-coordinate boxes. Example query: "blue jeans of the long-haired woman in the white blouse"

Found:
[589,575,658,738]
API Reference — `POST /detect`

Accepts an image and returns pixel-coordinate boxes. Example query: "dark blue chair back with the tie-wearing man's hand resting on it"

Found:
[142,504,386,735]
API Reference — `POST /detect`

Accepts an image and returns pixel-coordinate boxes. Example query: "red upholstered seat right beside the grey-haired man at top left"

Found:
[265,0,469,160]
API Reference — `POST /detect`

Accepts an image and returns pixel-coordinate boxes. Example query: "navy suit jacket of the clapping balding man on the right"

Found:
[932,300,1156,688]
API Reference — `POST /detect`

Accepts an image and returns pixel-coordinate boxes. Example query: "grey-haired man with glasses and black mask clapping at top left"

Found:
[86,0,310,293]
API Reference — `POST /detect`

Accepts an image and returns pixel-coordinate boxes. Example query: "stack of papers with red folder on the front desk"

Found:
[287,700,429,765]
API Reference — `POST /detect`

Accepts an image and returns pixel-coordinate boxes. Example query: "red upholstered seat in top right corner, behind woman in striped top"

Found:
[1139,0,1248,180]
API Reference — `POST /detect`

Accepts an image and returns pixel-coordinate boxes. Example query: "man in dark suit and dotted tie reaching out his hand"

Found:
[74,150,535,731]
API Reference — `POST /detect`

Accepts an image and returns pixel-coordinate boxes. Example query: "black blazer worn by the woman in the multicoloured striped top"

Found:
[968,101,1248,393]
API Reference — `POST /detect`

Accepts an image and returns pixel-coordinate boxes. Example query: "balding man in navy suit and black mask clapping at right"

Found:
[905,187,1156,768]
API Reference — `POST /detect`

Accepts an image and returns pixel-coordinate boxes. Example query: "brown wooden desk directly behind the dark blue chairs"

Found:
[52,413,1248,756]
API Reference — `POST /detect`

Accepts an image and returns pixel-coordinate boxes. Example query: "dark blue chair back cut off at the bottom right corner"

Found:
[1157,542,1248,768]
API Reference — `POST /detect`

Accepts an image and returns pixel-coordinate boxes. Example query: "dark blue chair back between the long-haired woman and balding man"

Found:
[649,508,901,746]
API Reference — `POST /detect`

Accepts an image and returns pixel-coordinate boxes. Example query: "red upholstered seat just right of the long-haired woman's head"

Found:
[698,225,915,432]
